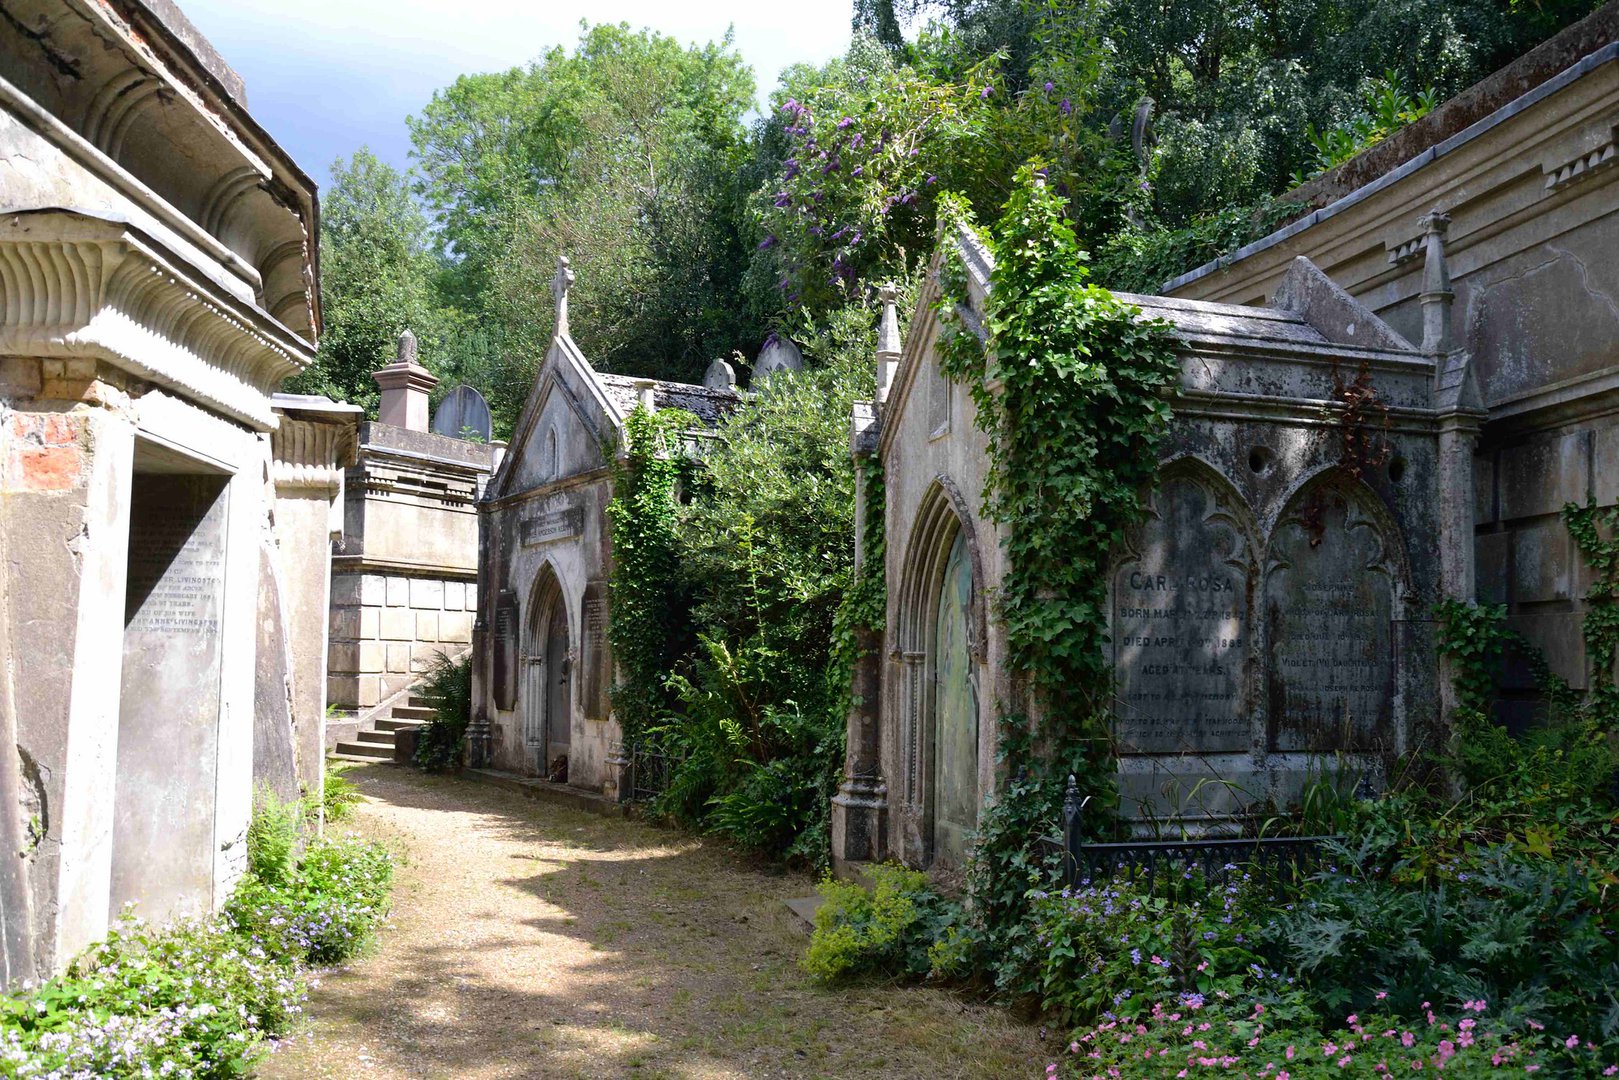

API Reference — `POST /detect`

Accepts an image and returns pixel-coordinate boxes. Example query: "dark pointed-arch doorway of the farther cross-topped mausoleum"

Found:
[523,565,573,780]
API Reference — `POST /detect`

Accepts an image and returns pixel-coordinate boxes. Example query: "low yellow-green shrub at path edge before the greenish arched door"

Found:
[803,863,960,984]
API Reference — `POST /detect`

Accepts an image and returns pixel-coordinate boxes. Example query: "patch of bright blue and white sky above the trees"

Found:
[180,0,852,189]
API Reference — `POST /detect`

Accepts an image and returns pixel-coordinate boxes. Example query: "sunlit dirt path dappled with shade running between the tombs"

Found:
[261,766,1047,1080]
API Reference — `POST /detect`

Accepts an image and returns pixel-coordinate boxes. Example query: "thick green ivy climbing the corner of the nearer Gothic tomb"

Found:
[936,165,1180,981]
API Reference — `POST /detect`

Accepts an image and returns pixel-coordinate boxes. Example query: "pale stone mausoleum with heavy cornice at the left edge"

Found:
[0,0,356,983]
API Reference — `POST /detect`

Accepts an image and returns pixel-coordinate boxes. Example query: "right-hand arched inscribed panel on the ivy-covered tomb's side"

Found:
[1264,489,1394,753]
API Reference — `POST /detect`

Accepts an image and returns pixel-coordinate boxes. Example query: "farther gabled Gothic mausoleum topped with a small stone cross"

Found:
[468,259,741,797]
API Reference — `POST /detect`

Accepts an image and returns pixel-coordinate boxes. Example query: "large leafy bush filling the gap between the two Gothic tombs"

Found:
[650,323,882,866]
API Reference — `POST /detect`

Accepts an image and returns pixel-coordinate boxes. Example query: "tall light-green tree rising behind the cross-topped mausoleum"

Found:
[410,24,764,424]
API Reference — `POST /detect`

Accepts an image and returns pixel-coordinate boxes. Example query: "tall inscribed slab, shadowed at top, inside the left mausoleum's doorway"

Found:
[110,473,227,921]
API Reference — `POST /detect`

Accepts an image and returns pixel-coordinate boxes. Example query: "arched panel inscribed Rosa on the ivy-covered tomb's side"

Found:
[1112,474,1253,753]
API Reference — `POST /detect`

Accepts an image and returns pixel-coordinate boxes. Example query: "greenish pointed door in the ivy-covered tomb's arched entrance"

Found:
[929,528,979,866]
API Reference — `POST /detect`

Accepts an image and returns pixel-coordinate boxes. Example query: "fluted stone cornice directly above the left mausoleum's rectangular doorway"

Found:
[0,210,314,431]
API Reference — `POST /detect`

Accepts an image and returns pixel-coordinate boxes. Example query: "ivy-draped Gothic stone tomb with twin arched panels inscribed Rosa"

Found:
[832,226,1481,871]
